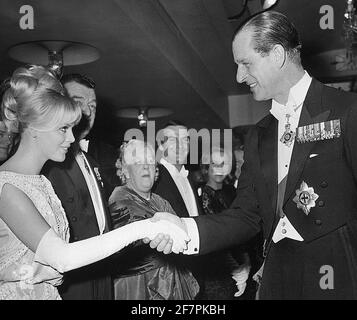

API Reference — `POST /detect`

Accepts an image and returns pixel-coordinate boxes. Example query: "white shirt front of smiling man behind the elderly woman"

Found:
[160,158,198,217]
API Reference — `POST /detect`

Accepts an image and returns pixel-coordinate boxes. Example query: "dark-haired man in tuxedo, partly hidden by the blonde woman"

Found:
[43,74,113,300]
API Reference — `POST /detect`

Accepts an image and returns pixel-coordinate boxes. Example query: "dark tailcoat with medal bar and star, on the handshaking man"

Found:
[196,79,357,298]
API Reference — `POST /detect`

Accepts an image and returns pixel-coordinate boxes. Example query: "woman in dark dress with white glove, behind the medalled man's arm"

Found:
[197,148,250,300]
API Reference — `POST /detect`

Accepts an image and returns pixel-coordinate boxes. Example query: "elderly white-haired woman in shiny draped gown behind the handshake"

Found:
[109,139,199,300]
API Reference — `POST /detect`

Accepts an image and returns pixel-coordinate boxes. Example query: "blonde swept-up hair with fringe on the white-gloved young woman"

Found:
[1,65,82,133]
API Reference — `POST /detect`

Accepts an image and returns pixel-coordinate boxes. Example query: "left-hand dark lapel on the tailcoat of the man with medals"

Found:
[258,115,278,212]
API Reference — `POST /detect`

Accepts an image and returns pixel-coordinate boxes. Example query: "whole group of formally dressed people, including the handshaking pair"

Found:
[0,11,357,300]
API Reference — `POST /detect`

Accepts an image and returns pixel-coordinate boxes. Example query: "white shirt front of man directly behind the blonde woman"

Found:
[76,151,105,234]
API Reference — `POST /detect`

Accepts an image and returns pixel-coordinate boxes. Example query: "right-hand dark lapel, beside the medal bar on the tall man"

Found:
[284,80,330,204]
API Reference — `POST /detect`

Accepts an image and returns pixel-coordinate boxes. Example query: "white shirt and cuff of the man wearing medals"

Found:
[183,71,312,254]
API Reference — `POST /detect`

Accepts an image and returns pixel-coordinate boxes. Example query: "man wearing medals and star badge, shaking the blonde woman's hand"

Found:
[150,11,357,299]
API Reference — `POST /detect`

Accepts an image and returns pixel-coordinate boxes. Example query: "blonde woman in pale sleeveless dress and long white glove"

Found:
[0,66,188,300]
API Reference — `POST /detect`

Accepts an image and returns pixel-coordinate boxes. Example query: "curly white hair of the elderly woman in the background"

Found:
[115,139,159,184]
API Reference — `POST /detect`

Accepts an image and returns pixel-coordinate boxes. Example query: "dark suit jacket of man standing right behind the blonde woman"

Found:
[42,150,112,300]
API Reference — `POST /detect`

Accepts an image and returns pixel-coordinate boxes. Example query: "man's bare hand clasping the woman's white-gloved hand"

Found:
[143,212,187,254]
